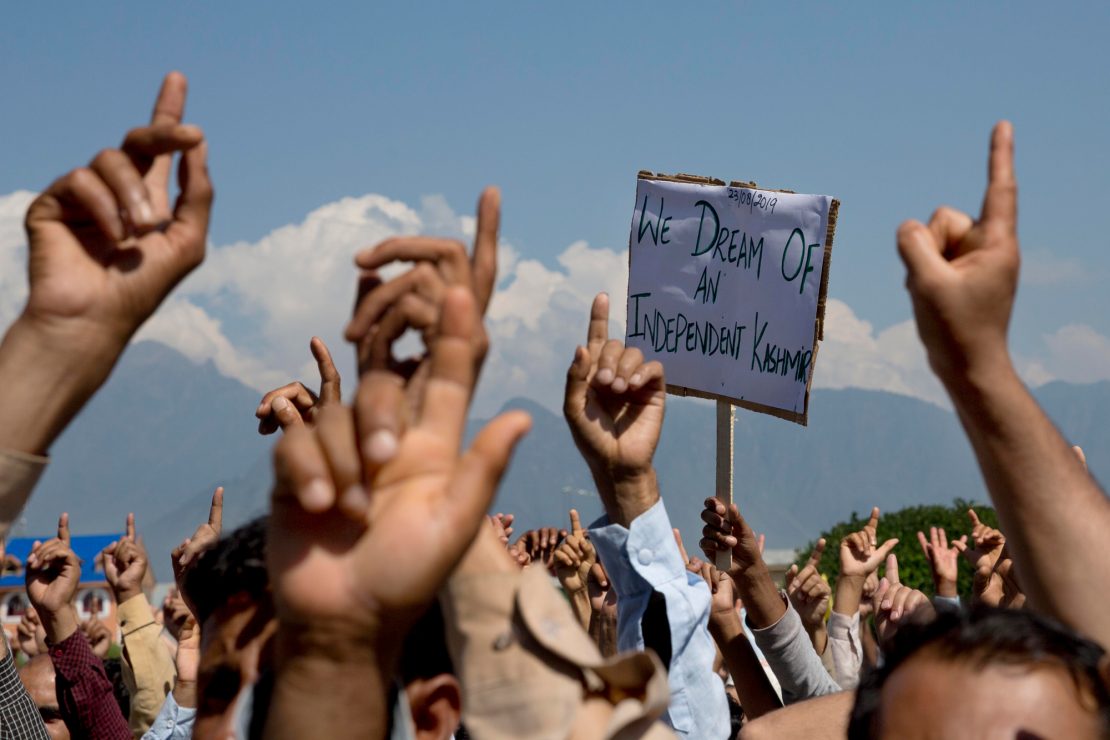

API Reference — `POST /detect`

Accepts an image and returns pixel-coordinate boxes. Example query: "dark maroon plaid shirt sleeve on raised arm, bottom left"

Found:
[50,630,131,740]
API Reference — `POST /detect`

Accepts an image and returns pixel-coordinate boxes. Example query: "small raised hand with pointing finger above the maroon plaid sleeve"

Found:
[27,514,81,643]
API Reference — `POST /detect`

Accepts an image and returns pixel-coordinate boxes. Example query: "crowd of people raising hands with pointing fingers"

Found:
[0,73,1110,739]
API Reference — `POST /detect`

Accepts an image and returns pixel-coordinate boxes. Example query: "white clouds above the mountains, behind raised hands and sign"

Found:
[0,191,1110,414]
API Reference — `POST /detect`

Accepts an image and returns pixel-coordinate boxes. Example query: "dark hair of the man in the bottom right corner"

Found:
[848,607,1110,740]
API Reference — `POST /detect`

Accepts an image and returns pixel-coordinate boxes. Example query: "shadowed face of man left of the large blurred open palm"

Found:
[194,599,278,738]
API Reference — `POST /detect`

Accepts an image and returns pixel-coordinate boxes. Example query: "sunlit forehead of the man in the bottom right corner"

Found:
[878,655,1100,740]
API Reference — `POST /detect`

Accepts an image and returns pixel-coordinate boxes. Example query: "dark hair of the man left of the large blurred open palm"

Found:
[183,516,270,625]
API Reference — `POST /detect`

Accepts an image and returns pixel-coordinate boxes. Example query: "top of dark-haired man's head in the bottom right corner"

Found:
[848,608,1110,739]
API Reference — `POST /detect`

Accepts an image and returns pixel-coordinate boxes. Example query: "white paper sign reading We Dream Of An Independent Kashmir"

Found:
[627,180,833,414]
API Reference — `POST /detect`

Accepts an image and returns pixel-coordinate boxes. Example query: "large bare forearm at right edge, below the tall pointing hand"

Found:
[946,363,1110,645]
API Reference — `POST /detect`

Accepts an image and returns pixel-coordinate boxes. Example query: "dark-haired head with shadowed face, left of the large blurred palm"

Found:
[183,517,278,740]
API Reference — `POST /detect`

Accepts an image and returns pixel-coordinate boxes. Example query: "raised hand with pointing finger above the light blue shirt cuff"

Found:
[563,293,667,521]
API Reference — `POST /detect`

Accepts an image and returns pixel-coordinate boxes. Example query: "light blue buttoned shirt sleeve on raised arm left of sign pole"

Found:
[589,499,731,740]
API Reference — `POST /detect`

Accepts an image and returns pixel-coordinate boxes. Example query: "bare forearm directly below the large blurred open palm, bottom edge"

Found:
[265,628,401,740]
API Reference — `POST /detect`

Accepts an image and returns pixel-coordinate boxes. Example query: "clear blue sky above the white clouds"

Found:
[0,2,1110,410]
